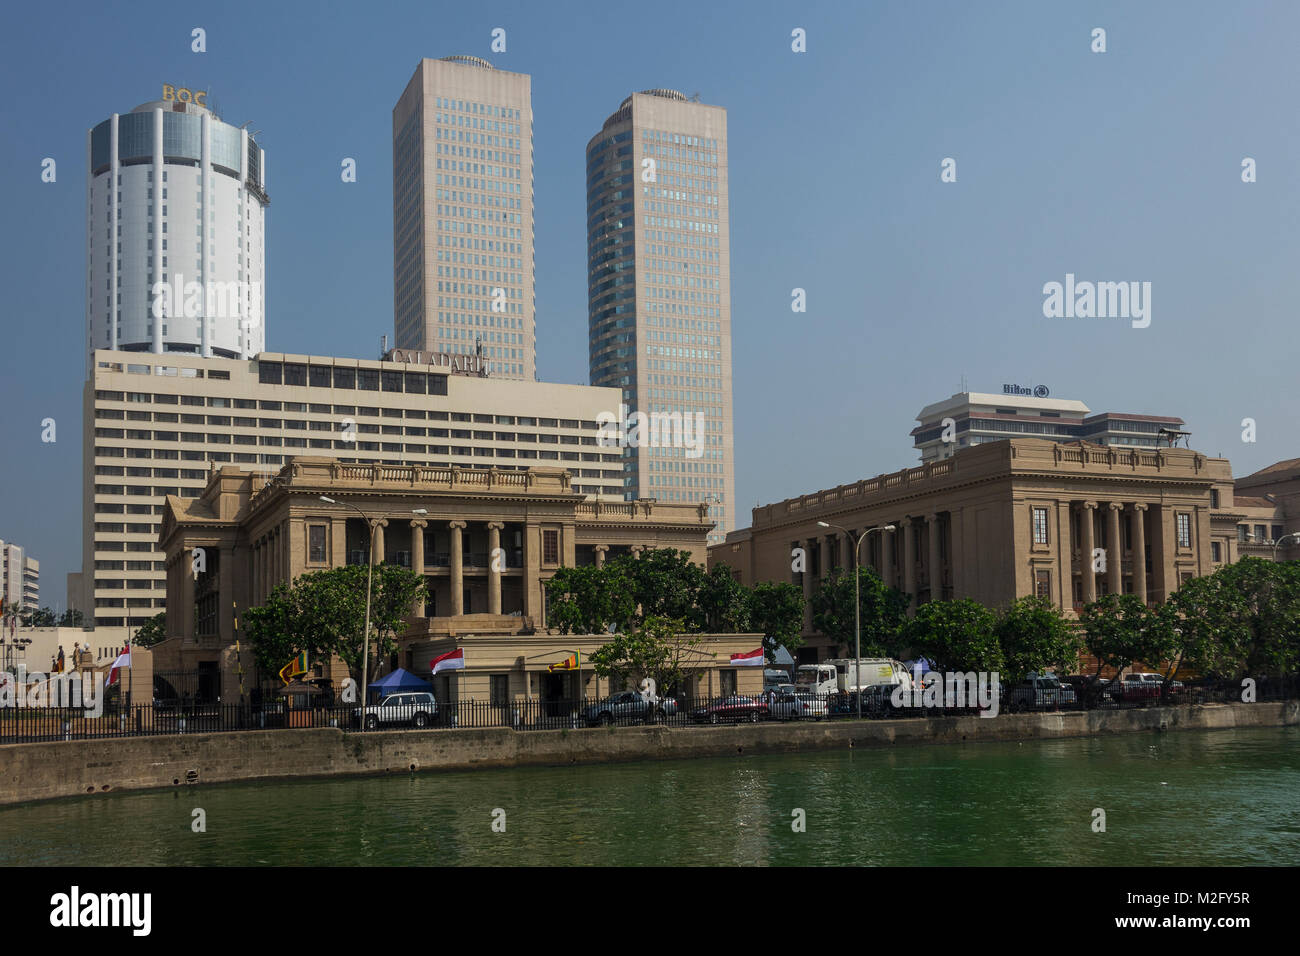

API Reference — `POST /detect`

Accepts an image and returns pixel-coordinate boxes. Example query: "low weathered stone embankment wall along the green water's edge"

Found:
[0,701,1300,804]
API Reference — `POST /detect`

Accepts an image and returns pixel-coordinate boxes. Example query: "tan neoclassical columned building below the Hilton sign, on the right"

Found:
[709,438,1300,659]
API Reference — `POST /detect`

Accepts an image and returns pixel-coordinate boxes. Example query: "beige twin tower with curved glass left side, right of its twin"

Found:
[586,90,735,544]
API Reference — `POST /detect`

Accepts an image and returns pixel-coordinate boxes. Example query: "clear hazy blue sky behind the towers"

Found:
[0,0,1300,606]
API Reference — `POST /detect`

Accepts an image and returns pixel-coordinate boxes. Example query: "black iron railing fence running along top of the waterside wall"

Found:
[0,676,1300,744]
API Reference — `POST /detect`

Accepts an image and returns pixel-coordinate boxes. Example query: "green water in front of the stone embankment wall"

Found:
[0,727,1300,866]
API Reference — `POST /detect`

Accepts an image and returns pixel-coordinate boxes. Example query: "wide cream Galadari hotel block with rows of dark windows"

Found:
[78,350,623,627]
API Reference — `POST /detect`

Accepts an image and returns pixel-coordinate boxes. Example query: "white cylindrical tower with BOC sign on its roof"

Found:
[86,86,270,358]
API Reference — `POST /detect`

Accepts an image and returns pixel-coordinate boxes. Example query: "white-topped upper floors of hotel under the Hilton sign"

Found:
[911,385,1187,462]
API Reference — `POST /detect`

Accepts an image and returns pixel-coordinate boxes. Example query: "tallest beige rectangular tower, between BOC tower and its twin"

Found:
[393,56,537,381]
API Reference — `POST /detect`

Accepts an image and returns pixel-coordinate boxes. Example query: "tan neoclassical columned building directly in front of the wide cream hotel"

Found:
[156,458,761,700]
